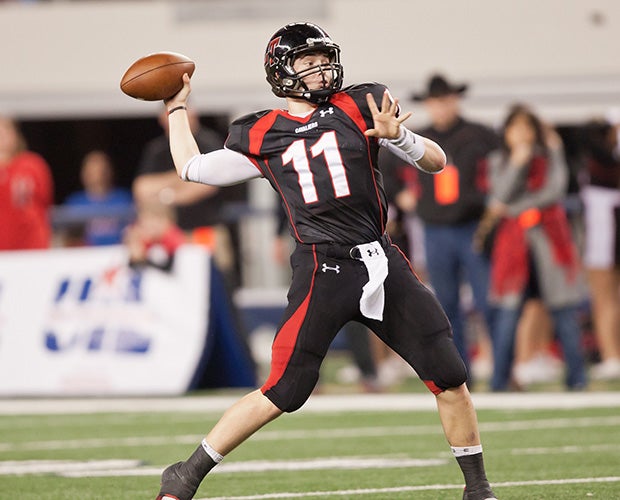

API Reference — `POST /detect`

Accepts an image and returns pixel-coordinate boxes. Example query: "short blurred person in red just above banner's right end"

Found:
[124,201,187,271]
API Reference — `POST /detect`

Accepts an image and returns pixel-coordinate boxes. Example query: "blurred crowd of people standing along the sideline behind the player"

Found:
[0,74,620,391]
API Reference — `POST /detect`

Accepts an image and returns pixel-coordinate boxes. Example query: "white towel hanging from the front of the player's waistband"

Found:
[355,241,388,321]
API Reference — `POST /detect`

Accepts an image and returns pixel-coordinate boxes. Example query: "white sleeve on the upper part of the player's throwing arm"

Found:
[181,148,262,186]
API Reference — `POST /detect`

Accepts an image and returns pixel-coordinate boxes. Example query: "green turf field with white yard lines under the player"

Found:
[0,393,620,500]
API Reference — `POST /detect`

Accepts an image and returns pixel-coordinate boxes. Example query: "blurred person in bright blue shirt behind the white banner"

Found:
[64,150,133,246]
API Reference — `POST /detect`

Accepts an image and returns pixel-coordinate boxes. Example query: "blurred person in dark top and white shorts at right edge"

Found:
[582,116,620,380]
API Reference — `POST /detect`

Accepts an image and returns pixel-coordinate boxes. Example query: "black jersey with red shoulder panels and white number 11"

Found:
[226,83,387,244]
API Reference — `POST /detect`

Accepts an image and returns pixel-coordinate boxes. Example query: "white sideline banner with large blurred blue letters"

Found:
[0,245,210,396]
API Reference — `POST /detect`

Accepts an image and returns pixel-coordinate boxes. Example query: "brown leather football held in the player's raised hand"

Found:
[121,52,196,101]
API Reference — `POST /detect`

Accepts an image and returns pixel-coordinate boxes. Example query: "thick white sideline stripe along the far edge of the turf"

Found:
[0,392,620,415]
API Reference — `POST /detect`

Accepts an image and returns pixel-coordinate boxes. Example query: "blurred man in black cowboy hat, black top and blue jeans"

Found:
[413,75,499,378]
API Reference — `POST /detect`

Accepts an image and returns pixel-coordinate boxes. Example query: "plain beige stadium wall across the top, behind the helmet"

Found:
[0,0,620,122]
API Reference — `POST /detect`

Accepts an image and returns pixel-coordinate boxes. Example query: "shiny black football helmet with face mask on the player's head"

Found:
[265,23,344,104]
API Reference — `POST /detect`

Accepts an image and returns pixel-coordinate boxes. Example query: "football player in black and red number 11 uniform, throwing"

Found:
[157,23,495,500]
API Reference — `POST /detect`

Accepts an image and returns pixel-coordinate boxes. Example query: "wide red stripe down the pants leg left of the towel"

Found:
[261,245,318,394]
